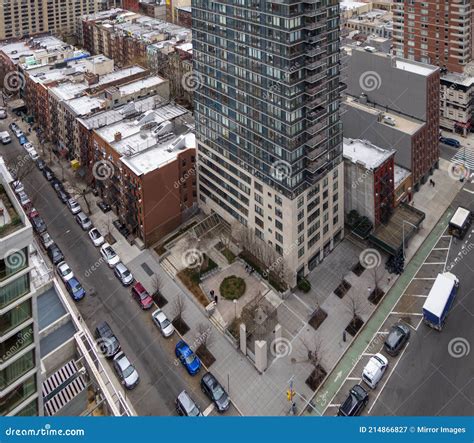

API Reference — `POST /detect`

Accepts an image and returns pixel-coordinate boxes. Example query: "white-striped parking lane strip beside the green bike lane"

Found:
[324,232,452,416]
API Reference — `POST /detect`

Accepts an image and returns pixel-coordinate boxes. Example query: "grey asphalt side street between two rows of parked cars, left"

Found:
[0,120,217,415]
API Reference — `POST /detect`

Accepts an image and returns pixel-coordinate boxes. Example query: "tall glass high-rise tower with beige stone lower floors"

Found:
[192,0,343,280]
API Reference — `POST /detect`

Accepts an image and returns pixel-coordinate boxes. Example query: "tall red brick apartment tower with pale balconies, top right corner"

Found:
[393,0,474,72]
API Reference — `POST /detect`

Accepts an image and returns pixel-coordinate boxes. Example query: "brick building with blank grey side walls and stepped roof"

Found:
[342,48,440,190]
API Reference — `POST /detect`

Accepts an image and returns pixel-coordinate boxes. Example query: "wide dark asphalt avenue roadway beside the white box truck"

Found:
[371,183,474,416]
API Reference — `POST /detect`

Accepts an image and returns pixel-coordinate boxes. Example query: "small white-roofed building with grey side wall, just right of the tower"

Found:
[343,139,395,226]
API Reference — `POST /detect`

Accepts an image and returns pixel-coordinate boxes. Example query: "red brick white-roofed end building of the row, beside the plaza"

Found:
[91,103,196,247]
